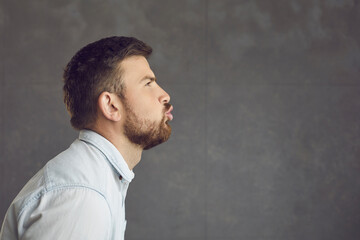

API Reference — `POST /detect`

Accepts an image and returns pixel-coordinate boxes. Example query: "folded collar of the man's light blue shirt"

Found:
[79,130,135,182]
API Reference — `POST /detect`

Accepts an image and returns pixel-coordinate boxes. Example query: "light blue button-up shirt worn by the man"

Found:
[0,130,134,240]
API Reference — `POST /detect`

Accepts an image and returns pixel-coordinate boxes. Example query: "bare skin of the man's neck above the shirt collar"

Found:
[91,124,143,170]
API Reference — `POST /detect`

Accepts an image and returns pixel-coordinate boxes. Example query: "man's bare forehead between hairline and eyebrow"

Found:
[120,56,154,79]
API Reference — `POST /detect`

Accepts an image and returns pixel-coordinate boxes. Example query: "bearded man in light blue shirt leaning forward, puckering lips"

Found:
[0,37,173,240]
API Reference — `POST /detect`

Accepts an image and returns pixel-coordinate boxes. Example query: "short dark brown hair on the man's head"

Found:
[63,36,152,130]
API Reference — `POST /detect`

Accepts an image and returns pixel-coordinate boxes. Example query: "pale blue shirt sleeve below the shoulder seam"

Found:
[18,187,111,240]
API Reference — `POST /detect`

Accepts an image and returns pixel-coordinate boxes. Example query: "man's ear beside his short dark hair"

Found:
[98,92,122,122]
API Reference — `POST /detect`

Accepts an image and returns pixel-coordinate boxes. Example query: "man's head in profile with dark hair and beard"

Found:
[63,37,172,149]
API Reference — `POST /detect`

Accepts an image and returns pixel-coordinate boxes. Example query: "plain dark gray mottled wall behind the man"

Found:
[0,0,360,240]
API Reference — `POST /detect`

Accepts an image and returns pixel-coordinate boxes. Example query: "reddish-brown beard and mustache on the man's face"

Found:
[124,101,171,150]
